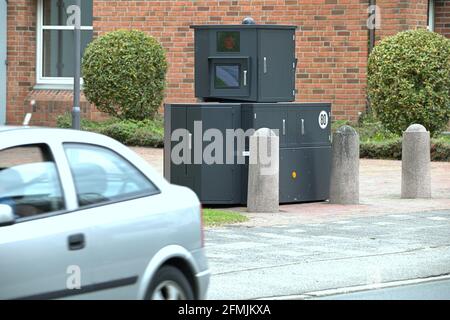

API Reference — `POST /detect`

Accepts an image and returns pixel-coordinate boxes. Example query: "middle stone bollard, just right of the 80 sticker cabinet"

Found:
[330,126,359,204]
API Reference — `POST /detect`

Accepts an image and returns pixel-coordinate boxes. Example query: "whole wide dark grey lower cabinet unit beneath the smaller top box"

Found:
[164,103,331,205]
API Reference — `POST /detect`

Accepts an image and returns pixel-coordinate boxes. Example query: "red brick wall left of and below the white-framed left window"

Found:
[6,0,109,126]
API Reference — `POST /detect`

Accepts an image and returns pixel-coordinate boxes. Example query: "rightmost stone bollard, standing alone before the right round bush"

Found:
[402,124,431,199]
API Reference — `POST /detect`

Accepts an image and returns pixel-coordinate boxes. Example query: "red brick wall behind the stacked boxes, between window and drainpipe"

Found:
[94,0,368,120]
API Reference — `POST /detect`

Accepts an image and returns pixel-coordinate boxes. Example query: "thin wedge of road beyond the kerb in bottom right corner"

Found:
[315,279,450,300]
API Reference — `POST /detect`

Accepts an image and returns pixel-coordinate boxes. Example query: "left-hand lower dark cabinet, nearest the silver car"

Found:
[164,103,242,204]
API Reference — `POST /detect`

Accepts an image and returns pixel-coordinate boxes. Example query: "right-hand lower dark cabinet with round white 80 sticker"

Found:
[241,103,331,203]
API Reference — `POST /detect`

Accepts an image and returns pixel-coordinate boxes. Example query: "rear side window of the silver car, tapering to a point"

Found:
[64,144,159,207]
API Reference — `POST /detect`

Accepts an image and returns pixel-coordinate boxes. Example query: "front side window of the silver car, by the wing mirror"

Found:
[0,144,65,219]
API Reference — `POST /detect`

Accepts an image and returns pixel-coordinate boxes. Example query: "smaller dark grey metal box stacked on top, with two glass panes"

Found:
[192,24,297,102]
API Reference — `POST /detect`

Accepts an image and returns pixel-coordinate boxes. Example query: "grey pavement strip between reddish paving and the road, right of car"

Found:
[206,210,450,300]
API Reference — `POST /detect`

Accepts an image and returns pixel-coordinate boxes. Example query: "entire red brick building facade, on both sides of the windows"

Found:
[3,0,450,125]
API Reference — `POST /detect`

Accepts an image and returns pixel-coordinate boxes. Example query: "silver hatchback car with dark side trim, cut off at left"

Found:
[0,126,210,300]
